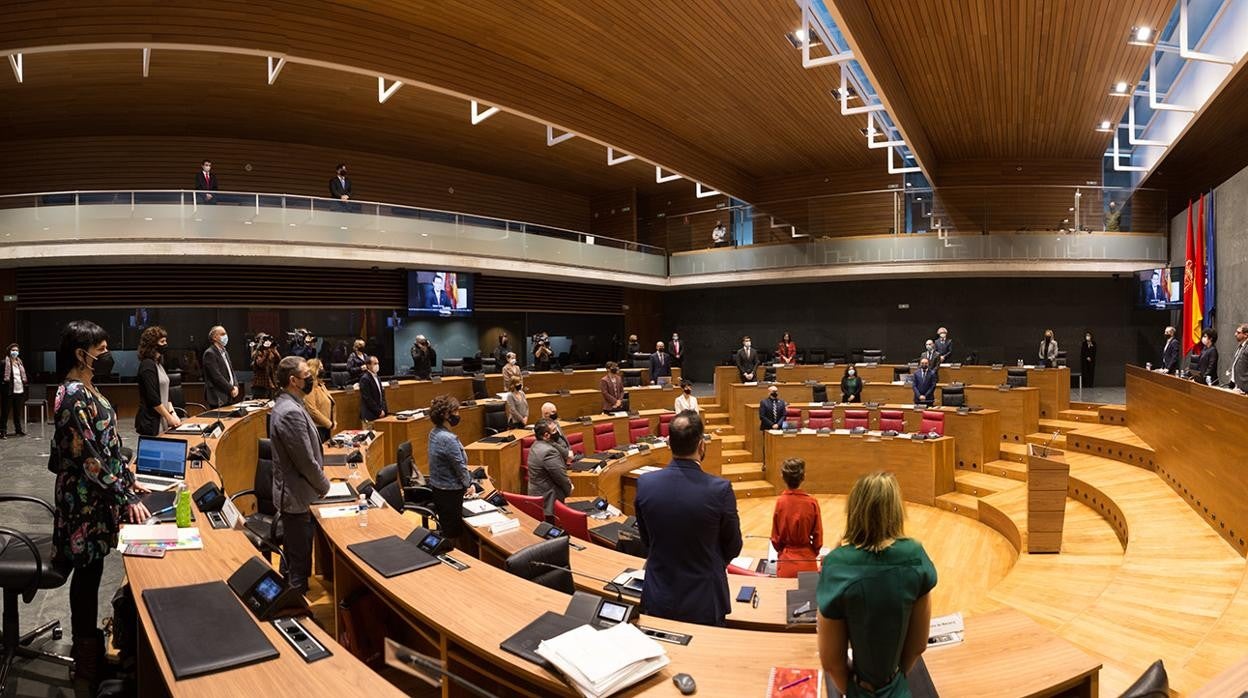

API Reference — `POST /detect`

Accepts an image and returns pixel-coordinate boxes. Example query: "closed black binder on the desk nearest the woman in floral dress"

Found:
[142,582,277,679]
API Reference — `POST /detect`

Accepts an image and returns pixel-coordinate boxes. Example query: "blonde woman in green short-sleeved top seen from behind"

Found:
[816,472,936,698]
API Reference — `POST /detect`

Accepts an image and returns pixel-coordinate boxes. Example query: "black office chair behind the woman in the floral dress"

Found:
[0,494,74,694]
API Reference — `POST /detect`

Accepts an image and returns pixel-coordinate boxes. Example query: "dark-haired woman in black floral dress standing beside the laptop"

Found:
[47,321,149,686]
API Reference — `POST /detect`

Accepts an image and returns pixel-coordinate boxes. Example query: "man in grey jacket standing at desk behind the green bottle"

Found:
[268,356,329,592]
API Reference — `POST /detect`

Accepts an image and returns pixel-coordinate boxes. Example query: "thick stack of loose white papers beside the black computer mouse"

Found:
[538,623,671,698]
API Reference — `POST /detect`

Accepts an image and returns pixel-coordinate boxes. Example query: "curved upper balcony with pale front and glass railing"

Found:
[0,187,1168,287]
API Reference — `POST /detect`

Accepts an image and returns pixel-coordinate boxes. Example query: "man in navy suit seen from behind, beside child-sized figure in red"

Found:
[634,412,741,626]
